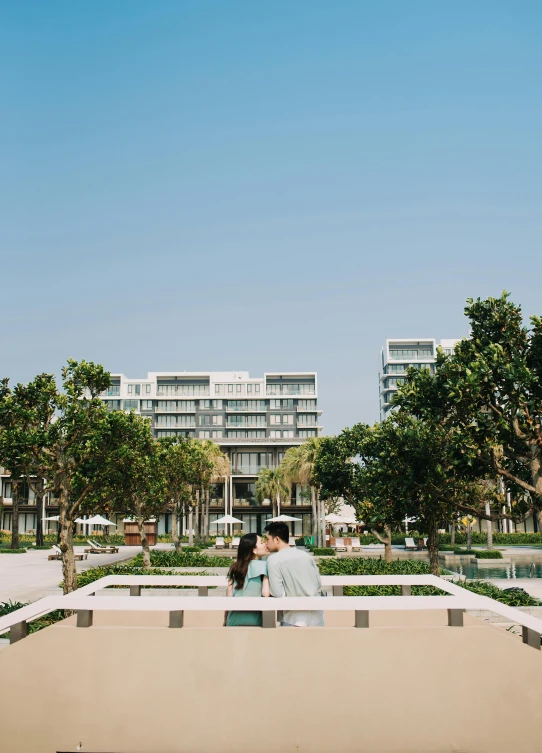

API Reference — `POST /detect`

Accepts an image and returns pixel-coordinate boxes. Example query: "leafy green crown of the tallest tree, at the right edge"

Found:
[396,292,542,528]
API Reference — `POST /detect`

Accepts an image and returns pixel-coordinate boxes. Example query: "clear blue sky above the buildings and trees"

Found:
[0,0,542,433]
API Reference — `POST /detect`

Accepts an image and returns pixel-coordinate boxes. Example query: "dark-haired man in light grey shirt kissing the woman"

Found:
[265,522,324,627]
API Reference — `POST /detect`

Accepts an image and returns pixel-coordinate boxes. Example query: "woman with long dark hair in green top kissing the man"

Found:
[224,533,269,627]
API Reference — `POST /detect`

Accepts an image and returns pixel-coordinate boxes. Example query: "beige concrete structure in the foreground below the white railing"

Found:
[0,612,542,753]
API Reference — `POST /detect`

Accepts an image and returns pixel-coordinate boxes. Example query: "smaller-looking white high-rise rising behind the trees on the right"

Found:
[378,338,458,421]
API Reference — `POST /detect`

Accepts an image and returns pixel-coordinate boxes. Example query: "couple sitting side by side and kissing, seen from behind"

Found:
[224,523,324,627]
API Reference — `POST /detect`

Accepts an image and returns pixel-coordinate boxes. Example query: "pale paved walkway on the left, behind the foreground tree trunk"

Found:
[0,546,141,602]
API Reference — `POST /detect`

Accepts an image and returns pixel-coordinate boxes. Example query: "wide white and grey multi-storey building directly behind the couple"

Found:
[0,371,322,535]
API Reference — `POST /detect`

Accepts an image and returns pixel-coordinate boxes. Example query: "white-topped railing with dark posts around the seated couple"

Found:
[0,575,542,649]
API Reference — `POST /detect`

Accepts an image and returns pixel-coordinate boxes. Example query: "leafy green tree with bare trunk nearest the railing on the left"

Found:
[0,359,110,593]
